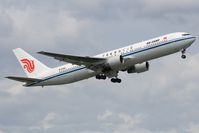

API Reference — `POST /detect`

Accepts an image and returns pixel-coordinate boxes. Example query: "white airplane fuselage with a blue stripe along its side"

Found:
[26,32,195,86]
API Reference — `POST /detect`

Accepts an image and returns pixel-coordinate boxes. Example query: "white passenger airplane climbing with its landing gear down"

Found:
[6,32,196,87]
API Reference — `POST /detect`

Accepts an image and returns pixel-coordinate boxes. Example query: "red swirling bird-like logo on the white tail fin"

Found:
[21,59,35,73]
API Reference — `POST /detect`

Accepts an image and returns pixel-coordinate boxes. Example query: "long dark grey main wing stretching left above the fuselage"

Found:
[38,51,106,71]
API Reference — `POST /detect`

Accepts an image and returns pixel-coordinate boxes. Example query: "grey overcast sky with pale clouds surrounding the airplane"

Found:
[0,0,199,133]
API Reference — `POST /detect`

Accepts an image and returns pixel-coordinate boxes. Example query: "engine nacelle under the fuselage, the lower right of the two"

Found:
[127,62,149,73]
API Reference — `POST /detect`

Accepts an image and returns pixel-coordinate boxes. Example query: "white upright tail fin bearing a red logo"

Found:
[13,48,50,78]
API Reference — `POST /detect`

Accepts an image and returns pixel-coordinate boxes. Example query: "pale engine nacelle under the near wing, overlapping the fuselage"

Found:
[106,55,124,70]
